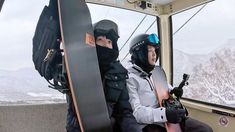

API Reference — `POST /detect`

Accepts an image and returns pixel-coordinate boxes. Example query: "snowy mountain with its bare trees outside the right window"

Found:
[174,39,235,107]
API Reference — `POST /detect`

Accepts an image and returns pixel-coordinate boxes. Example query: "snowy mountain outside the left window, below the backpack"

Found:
[0,68,64,104]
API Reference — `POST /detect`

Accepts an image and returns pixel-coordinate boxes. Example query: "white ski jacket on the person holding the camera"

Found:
[127,65,172,125]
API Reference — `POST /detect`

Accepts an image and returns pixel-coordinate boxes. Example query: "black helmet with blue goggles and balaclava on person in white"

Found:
[129,34,160,72]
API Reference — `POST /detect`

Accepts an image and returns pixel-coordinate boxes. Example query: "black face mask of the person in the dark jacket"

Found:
[96,45,119,74]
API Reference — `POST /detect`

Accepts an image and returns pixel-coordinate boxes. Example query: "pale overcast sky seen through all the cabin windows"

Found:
[0,0,235,70]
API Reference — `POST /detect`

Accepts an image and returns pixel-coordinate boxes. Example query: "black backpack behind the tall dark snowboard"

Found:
[32,6,68,93]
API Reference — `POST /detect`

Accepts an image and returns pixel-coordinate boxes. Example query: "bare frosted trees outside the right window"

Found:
[184,49,235,107]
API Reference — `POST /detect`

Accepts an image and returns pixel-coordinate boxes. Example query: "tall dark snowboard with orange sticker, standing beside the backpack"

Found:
[58,0,112,132]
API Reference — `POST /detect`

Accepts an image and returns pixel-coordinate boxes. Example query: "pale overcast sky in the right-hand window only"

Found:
[173,0,235,54]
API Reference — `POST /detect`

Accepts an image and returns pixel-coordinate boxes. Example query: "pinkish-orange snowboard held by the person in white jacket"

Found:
[152,66,182,132]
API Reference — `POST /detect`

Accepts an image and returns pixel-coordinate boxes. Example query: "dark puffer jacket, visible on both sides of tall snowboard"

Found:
[66,61,134,132]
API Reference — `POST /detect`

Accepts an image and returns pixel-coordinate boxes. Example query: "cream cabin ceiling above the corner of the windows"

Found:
[85,0,213,16]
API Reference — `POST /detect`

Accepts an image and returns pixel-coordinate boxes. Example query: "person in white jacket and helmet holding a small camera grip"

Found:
[127,34,212,132]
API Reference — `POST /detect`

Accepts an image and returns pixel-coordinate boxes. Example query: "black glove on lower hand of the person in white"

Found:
[166,108,186,123]
